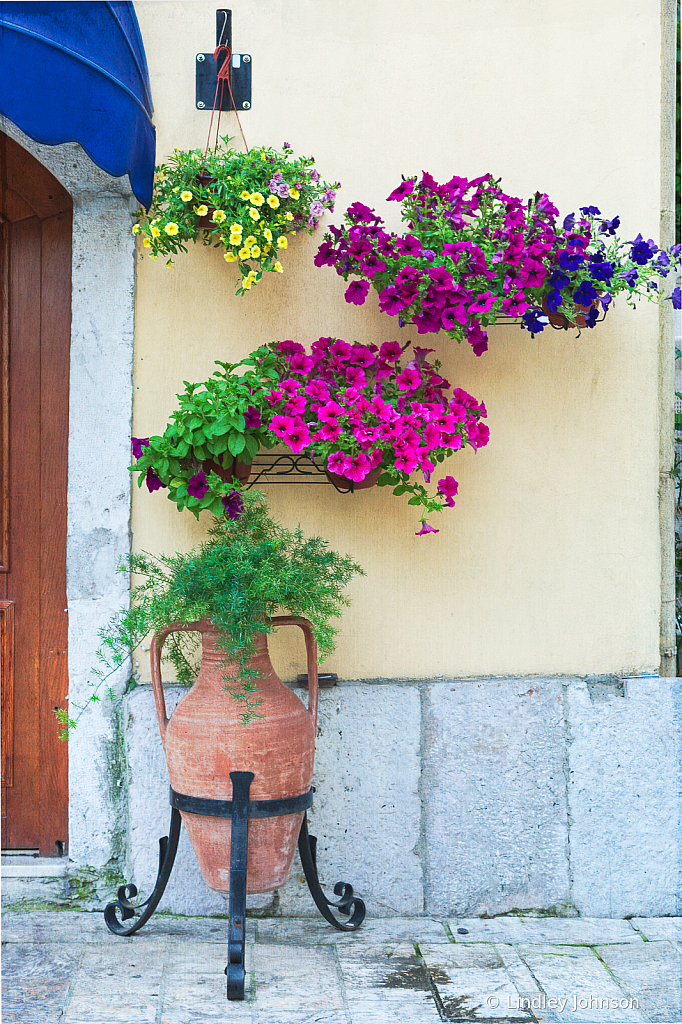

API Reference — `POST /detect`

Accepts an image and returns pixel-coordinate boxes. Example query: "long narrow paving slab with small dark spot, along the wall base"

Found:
[447,918,642,945]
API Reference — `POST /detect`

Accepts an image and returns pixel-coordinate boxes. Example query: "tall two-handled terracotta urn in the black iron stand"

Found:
[152,615,317,893]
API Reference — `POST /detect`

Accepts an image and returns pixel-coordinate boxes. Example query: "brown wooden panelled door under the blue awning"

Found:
[0,132,72,856]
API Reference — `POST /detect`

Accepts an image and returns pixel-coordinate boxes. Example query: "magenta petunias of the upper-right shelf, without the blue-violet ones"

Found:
[315,172,557,355]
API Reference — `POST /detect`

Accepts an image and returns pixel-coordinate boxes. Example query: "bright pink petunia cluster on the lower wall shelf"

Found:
[246,338,488,535]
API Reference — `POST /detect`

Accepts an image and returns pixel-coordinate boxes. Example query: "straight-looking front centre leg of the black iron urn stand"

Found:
[225,771,254,999]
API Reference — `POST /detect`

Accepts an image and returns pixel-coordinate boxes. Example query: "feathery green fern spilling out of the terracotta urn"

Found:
[57,492,364,731]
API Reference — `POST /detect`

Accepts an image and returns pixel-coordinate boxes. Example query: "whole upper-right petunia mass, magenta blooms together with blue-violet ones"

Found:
[315,172,680,355]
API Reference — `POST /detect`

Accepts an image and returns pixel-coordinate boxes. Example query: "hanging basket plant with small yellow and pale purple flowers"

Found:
[133,137,339,295]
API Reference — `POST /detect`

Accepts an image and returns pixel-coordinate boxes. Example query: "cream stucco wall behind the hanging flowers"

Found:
[132,0,660,679]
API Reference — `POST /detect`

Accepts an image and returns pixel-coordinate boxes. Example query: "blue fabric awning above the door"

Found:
[0,0,156,208]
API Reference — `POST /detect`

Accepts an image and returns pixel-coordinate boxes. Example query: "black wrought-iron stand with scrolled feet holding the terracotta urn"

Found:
[104,771,366,999]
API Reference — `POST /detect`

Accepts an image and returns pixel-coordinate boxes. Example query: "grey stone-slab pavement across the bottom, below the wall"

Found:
[2,911,682,1024]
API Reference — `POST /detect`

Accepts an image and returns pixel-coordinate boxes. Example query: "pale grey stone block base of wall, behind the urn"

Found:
[119,676,682,918]
